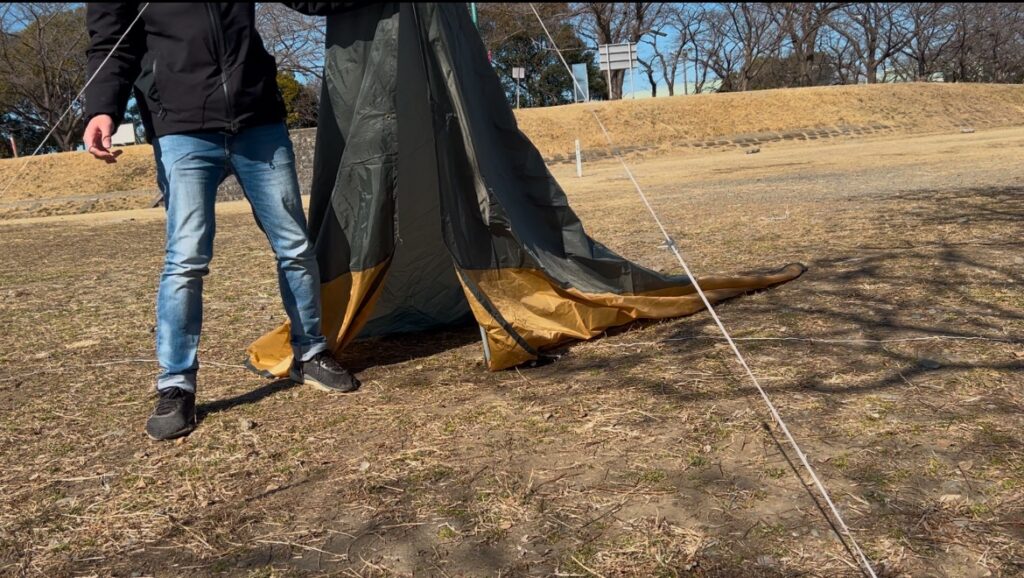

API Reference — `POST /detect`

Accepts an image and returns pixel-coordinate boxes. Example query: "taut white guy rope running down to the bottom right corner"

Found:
[529,3,878,578]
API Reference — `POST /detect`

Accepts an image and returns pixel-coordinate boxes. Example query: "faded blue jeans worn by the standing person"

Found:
[154,124,327,391]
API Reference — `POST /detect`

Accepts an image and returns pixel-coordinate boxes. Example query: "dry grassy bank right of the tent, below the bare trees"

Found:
[519,84,1024,157]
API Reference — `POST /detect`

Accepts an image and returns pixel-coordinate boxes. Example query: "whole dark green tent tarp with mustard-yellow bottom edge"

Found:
[243,3,804,376]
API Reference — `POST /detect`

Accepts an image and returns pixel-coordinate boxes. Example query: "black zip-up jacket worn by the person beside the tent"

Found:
[85,2,361,137]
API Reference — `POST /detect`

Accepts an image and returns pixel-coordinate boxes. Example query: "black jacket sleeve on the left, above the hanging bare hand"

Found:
[85,2,144,124]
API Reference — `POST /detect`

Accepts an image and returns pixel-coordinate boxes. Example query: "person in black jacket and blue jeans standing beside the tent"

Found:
[84,2,359,440]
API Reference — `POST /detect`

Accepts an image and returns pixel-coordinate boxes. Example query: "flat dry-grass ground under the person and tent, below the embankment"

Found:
[0,115,1024,577]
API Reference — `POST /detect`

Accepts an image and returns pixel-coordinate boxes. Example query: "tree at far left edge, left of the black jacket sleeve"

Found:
[0,3,88,151]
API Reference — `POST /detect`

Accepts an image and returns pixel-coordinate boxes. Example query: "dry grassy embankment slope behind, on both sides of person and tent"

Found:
[0,84,1024,207]
